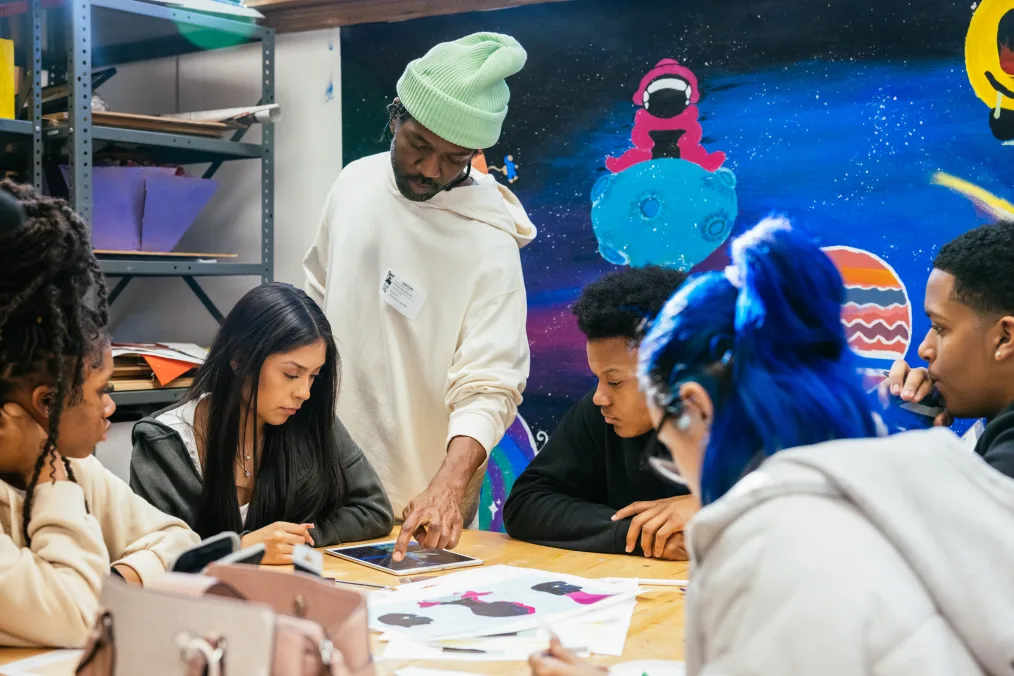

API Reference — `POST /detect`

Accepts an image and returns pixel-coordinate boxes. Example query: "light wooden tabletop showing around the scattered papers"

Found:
[0,529,687,675]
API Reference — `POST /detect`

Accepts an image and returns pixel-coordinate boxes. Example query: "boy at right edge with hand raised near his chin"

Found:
[885,223,1014,477]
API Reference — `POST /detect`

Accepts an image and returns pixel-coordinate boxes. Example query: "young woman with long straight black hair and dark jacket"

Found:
[130,284,394,564]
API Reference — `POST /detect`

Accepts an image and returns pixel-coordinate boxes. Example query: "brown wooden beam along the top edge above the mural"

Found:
[246,0,569,32]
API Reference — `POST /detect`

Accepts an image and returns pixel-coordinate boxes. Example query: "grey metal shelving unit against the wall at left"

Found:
[9,0,275,405]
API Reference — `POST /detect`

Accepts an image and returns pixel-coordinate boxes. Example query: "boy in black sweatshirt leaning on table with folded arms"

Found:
[504,267,699,560]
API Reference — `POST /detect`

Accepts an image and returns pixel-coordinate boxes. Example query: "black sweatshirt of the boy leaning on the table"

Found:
[504,392,687,555]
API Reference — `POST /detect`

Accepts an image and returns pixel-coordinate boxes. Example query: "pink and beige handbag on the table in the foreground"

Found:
[76,564,375,676]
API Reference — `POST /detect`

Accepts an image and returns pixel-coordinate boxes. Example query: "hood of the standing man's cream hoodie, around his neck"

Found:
[383,153,536,248]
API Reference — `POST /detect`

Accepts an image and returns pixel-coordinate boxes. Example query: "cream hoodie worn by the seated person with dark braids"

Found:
[0,457,200,648]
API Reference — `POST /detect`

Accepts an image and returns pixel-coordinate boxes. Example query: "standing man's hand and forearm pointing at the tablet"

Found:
[391,437,486,561]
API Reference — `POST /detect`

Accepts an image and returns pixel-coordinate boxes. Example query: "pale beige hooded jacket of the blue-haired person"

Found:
[686,429,1014,676]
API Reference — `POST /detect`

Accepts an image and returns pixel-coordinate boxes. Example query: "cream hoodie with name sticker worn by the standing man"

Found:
[303,153,535,517]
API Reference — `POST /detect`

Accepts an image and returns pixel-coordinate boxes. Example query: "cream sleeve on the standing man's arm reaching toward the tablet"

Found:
[444,285,530,453]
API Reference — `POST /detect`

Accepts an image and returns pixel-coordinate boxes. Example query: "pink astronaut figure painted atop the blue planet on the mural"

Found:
[605,59,725,173]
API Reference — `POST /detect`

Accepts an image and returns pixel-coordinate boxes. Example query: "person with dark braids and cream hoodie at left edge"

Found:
[0,181,200,647]
